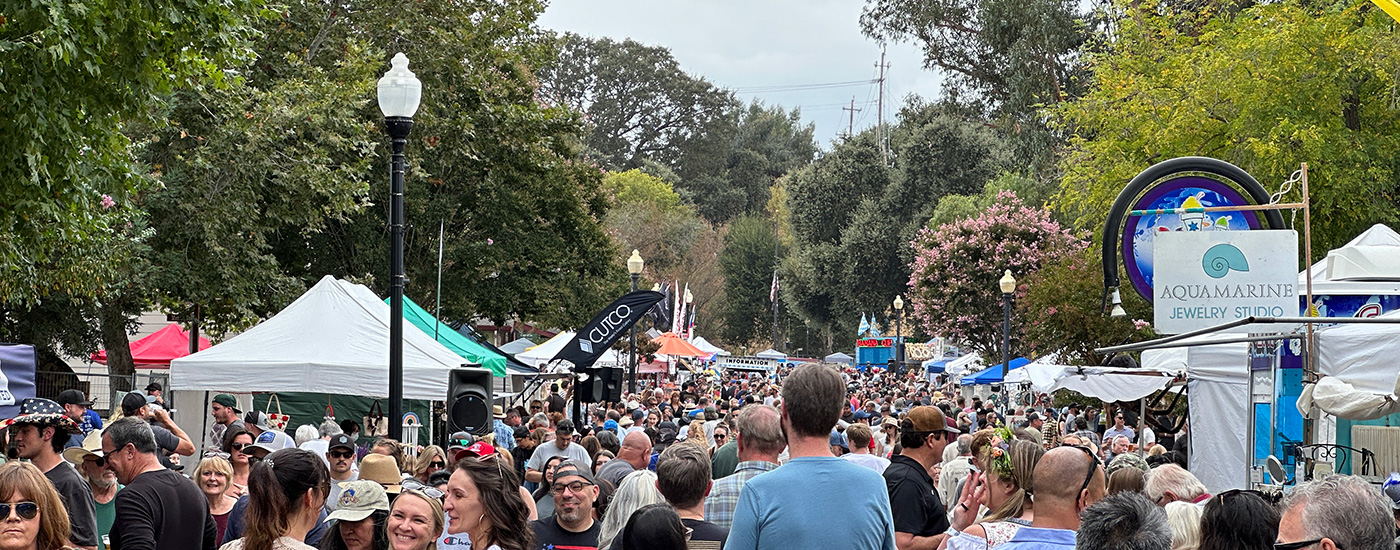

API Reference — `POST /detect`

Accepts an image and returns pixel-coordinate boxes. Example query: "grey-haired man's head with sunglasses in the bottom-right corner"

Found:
[1274,474,1394,550]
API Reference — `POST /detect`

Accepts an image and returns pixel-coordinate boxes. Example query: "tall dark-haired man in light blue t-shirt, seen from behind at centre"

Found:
[724,364,895,550]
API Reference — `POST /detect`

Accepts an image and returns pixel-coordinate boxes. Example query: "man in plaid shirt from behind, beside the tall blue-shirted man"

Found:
[704,404,787,529]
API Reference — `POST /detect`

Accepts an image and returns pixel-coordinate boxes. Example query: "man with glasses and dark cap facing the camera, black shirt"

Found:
[531,460,602,550]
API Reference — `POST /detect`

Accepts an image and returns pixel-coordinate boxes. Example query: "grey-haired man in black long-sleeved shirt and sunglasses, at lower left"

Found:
[102,417,217,550]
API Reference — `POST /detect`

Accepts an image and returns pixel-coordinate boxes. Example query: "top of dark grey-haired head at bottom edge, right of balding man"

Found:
[1074,491,1172,550]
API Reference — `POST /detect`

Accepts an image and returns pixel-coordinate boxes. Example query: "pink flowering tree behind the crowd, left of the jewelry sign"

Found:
[909,190,1088,362]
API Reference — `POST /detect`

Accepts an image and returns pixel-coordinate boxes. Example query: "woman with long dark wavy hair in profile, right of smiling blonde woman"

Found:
[442,460,532,550]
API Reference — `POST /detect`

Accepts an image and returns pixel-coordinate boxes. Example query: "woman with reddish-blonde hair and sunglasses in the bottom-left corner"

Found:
[0,462,73,550]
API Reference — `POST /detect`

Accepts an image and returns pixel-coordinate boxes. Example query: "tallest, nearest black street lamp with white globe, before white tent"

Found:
[378,52,423,441]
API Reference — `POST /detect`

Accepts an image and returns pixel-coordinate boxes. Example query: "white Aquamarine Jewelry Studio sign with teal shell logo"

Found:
[1152,231,1298,334]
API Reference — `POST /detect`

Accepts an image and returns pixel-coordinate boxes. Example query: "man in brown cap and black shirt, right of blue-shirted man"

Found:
[883,406,959,550]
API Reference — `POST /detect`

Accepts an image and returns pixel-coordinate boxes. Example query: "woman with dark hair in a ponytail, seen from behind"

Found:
[220,449,330,550]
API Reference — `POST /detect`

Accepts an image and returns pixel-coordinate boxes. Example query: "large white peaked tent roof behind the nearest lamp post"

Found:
[169,276,463,400]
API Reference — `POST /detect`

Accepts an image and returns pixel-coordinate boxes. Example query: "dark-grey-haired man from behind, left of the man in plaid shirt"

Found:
[657,445,729,550]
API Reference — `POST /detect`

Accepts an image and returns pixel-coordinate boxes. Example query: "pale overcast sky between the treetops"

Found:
[539,0,939,148]
